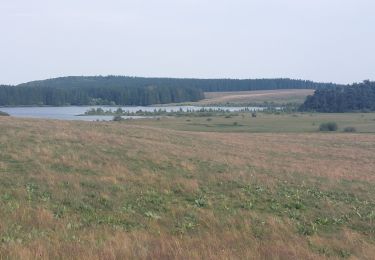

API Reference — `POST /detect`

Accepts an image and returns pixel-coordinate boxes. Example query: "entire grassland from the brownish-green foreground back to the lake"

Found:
[0,113,375,259]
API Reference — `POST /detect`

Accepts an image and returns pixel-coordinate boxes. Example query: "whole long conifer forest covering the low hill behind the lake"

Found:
[0,76,336,106]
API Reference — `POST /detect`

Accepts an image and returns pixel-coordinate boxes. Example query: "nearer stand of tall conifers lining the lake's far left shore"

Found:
[0,82,203,106]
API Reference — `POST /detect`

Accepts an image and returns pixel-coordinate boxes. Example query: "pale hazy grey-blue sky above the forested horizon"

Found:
[0,0,375,84]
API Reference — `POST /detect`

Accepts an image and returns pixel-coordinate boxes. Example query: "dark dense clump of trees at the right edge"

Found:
[300,81,375,112]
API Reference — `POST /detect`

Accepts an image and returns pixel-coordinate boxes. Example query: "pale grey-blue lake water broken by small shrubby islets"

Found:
[0,106,263,121]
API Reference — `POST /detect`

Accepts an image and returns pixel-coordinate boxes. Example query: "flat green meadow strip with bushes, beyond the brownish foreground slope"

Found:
[127,112,375,133]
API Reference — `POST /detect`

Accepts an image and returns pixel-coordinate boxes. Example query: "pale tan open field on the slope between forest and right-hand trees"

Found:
[199,89,314,104]
